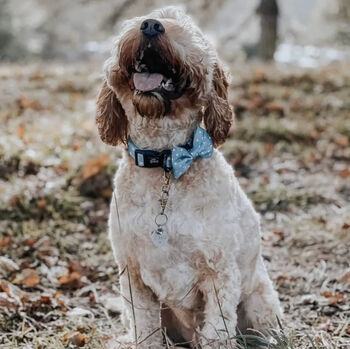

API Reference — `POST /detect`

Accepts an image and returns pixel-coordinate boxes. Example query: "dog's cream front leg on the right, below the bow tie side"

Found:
[199,267,241,349]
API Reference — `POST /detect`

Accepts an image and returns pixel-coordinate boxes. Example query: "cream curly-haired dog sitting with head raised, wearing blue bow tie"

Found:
[96,7,281,348]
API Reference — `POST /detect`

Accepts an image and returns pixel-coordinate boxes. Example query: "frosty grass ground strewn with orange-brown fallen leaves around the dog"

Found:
[0,63,350,349]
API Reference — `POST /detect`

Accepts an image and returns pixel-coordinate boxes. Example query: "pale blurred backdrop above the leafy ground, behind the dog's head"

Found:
[0,0,350,67]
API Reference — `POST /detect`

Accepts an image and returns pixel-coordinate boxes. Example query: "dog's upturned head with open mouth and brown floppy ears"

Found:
[96,7,232,145]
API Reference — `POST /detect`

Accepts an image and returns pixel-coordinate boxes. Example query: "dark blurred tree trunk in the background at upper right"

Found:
[257,0,279,61]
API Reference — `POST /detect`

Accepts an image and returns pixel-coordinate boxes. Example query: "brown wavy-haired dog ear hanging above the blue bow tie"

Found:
[203,63,233,146]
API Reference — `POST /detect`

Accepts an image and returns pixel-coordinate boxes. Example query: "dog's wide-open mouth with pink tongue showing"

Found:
[130,43,186,100]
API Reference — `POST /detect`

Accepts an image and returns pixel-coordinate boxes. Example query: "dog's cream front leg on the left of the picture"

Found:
[116,268,163,349]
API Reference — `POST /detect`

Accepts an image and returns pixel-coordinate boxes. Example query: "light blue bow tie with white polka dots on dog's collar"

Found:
[171,126,213,179]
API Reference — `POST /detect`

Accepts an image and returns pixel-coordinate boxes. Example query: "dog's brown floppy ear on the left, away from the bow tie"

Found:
[96,81,128,145]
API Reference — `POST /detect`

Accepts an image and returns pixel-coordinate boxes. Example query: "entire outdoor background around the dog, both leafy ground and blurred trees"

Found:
[0,0,350,349]
